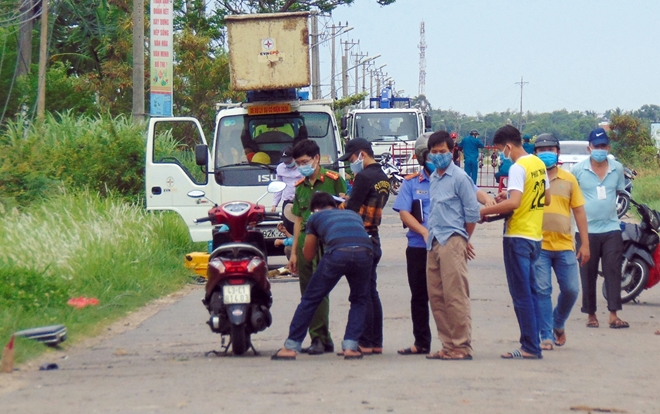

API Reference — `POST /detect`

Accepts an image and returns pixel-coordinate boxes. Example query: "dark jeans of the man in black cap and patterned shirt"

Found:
[360,235,383,348]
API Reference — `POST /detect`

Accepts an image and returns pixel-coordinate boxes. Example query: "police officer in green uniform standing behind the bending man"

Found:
[289,139,346,355]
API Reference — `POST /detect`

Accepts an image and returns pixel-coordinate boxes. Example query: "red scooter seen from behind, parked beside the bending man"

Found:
[188,181,286,355]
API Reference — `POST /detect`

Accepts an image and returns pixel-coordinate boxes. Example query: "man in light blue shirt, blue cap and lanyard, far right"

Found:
[571,128,629,329]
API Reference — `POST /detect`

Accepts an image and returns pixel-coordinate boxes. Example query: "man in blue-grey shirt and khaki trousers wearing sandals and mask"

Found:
[426,131,480,360]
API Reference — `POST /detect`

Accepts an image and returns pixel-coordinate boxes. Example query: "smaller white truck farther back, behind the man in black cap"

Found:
[341,87,431,172]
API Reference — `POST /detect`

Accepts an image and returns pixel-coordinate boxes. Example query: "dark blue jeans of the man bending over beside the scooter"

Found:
[284,247,373,351]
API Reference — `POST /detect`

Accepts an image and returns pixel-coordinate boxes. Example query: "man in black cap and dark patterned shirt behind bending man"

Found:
[339,138,390,354]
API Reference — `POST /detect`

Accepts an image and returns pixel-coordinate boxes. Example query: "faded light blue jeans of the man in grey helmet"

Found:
[534,250,580,341]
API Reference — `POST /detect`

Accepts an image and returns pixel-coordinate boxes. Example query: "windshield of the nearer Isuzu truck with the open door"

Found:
[214,112,337,185]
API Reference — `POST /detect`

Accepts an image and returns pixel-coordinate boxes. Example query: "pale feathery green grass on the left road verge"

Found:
[0,192,193,362]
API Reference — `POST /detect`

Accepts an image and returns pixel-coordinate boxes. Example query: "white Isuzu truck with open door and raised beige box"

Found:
[145,12,342,254]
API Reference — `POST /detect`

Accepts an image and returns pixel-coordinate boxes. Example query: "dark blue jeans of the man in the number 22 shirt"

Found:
[502,237,541,355]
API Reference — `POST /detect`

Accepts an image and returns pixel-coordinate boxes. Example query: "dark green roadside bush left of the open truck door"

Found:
[0,112,145,206]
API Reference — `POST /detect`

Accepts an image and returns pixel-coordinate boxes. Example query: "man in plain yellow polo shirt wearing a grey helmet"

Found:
[534,134,591,351]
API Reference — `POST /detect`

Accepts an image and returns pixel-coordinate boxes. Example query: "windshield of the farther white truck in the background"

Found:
[354,112,419,142]
